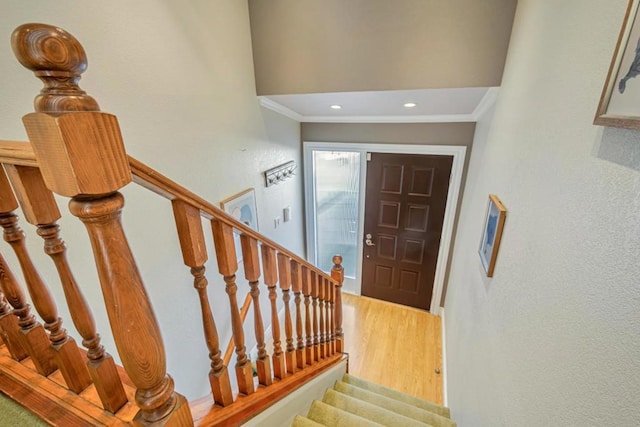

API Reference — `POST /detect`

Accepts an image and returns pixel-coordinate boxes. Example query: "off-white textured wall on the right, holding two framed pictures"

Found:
[445,0,640,426]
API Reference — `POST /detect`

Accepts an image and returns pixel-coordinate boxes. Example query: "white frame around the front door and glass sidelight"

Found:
[302,141,467,314]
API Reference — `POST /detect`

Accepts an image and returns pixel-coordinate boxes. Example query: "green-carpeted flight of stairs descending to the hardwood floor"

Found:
[292,374,456,427]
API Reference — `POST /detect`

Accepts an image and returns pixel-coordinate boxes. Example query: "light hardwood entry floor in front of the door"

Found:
[342,294,443,404]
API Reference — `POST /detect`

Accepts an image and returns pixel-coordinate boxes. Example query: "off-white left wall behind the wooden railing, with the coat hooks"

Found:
[0,0,304,398]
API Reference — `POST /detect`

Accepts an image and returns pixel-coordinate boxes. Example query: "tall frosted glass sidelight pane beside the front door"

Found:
[313,151,360,277]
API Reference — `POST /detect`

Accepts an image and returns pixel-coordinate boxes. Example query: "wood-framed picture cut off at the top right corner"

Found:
[593,0,640,130]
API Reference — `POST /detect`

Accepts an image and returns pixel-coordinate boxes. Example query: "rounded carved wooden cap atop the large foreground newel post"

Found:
[11,24,100,113]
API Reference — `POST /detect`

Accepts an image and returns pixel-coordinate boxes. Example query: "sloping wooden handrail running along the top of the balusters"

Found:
[0,140,335,283]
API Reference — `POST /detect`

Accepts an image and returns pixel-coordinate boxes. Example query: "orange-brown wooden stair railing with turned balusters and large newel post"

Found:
[0,24,347,426]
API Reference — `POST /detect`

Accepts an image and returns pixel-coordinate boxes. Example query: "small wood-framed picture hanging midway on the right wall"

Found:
[478,194,507,277]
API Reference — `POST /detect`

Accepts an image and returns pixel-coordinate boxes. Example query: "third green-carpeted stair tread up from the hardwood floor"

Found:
[322,389,429,427]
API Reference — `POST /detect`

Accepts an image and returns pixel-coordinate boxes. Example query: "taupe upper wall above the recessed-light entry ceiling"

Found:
[249,0,516,95]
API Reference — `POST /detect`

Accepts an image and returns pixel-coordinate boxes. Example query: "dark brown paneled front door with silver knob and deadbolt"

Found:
[362,153,453,310]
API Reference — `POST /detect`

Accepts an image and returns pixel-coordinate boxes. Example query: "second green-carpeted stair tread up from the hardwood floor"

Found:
[333,381,456,427]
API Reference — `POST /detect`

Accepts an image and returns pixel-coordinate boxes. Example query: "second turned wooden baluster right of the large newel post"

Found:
[211,220,254,395]
